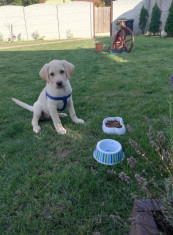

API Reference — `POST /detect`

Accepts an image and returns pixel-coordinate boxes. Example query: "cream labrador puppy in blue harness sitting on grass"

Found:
[12,60,84,134]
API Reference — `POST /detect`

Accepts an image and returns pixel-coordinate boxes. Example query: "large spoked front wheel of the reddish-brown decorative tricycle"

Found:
[114,27,134,53]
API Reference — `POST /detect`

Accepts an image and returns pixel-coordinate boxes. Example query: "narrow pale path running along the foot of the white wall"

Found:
[0,38,91,50]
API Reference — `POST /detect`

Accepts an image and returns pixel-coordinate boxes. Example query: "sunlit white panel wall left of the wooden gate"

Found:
[0,2,93,40]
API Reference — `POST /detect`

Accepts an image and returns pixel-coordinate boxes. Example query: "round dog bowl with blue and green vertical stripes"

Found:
[93,139,125,165]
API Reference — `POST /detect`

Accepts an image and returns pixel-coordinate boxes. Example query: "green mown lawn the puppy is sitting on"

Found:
[0,36,173,235]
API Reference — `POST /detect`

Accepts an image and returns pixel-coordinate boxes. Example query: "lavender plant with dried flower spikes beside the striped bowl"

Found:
[119,116,173,234]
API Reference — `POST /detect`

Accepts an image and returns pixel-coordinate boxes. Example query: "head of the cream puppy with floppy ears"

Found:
[39,60,74,89]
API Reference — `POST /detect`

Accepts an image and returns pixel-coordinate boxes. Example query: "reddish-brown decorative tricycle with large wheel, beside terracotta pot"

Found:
[108,20,134,54]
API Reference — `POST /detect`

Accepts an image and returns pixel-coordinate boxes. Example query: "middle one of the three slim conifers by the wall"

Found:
[149,3,161,36]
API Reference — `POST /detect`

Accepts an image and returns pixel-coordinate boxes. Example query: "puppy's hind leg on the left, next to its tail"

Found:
[32,102,42,133]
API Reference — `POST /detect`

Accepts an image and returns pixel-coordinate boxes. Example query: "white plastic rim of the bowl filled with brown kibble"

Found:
[102,117,126,135]
